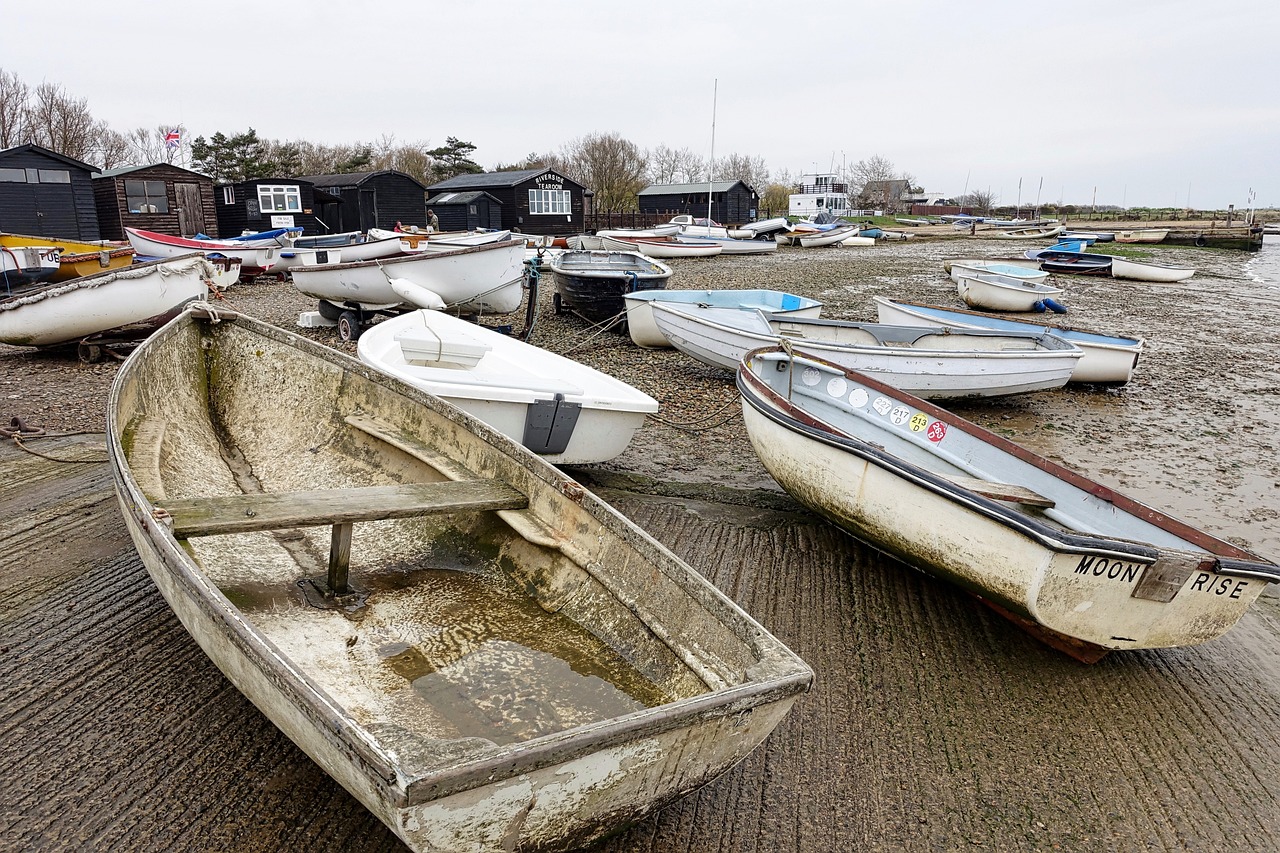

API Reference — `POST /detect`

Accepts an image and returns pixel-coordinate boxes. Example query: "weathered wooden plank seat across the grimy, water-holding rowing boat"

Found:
[159,480,529,539]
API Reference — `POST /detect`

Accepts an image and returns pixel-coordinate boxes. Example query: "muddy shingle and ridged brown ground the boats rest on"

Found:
[0,222,1280,853]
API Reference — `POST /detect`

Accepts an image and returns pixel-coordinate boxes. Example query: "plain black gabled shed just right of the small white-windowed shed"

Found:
[298,169,426,233]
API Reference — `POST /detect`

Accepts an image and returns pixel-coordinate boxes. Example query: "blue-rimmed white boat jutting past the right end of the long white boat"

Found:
[872,296,1143,384]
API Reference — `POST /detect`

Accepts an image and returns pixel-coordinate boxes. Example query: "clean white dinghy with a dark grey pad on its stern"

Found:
[357,310,658,465]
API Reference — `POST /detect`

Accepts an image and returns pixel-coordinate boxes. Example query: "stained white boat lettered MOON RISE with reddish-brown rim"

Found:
[737,351,1280,661]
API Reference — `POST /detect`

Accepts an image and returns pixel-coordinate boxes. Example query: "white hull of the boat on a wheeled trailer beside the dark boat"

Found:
[292,240,525,314]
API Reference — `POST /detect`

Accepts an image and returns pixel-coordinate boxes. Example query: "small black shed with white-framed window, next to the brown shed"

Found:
[214,178,327,237]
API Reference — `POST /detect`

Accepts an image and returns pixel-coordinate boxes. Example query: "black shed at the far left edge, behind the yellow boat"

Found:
[0,145,102,241]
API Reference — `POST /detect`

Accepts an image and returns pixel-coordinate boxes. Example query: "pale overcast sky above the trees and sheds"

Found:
[0,0,1280,209]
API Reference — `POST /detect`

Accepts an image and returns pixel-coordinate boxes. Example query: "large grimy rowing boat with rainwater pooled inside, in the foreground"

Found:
[108,311,813,852]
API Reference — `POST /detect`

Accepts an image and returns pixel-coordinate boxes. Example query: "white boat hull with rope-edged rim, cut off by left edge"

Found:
[0,254,214,347]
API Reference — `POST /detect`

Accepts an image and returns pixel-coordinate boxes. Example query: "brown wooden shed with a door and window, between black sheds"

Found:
[93,163,219,240]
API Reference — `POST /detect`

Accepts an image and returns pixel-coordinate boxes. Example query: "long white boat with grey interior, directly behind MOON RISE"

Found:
[652,302,1083,400]
